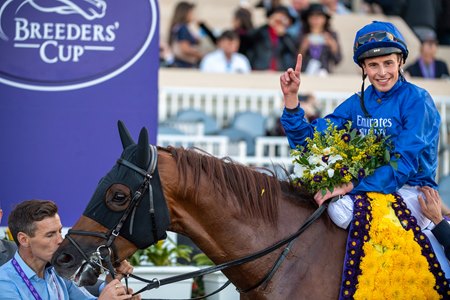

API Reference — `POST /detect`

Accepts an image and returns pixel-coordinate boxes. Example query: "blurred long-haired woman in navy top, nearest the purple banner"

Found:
[169,1,203,68]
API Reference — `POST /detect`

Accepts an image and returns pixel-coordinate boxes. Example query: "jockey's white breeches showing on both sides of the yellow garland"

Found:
[328,185,450,278]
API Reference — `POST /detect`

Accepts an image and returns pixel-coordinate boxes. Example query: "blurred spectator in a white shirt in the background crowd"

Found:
[200,30,251,73]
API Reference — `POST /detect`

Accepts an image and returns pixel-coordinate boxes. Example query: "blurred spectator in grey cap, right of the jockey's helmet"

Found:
[405,28,449,79]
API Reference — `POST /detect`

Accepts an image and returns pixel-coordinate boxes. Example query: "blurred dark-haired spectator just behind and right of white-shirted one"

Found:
[232,7,254,56]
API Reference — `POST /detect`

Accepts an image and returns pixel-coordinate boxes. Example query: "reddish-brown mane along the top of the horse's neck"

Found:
[159,146,313,222]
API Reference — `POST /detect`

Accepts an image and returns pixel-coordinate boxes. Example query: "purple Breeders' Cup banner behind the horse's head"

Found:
[0,0,159,226]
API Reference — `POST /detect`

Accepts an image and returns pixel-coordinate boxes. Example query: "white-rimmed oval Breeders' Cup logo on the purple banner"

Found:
[0,0,158,91]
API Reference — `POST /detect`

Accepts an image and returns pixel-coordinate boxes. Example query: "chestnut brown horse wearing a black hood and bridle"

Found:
[52,122,347,299]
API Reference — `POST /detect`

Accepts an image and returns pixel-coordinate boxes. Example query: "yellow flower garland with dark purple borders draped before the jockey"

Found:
[340,193,450,299]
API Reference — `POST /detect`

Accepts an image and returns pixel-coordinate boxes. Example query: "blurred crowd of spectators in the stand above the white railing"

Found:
[160,0,450,78]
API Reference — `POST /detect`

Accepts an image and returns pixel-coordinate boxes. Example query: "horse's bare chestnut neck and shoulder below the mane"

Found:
[160,154,346,299]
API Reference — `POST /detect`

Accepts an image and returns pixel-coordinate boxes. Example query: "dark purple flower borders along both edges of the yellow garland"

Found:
[339,194,450,300]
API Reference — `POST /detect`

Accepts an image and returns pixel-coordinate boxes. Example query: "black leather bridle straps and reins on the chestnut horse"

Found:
[66,145,329,299]
